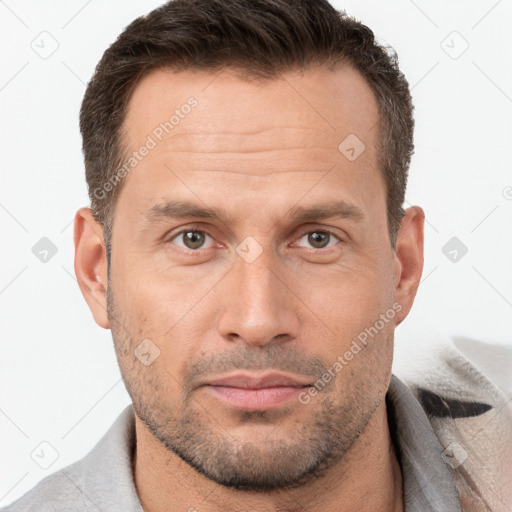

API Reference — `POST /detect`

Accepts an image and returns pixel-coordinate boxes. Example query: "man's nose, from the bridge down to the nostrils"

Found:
[217,250,299,346]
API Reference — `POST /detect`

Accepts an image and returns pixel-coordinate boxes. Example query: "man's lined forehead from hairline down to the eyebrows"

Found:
[114,66,384,224]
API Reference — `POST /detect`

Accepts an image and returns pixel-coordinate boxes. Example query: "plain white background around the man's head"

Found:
[0,0,512,505]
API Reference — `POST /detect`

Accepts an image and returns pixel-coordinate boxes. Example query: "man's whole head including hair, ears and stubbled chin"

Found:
[75,0,423,491]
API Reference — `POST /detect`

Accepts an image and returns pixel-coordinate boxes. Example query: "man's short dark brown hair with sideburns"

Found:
[80,0,414,252]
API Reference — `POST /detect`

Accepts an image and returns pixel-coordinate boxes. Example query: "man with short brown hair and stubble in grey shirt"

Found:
[6,0,510,512]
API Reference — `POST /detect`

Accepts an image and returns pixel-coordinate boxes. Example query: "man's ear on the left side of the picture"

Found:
[74,208,110,329]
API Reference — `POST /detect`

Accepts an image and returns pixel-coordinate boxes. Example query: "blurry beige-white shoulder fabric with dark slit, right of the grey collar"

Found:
[394,337,512,511]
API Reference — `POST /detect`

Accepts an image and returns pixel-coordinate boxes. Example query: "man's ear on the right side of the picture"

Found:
[395,206,425,325]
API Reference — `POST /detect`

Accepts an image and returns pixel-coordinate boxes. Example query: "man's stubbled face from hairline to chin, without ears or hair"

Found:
[108,67,403,490]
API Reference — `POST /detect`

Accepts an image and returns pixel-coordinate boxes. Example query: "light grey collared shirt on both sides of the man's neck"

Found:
[3,375,461,512]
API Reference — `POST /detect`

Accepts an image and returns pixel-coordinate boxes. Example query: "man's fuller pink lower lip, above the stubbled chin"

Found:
[206,385,305,411]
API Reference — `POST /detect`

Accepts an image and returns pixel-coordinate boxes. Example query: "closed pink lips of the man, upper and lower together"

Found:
[203,373,312,411]
